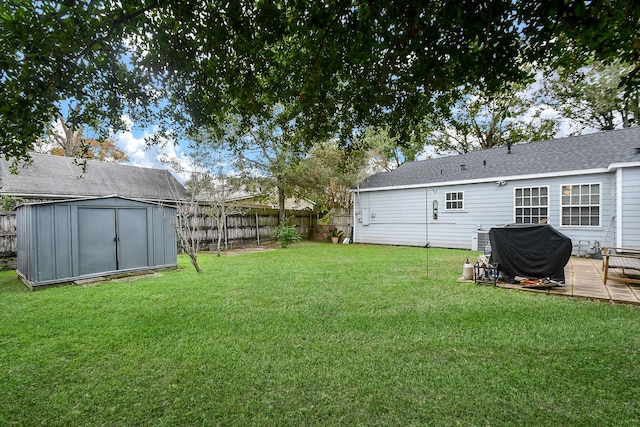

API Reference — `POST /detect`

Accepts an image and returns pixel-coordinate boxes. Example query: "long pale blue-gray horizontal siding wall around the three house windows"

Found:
[354,173,620,252]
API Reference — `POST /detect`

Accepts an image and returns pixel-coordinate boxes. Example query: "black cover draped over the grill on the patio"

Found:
[489,224,572,282]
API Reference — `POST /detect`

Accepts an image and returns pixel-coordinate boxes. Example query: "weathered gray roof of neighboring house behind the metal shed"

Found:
[0,153,186,201]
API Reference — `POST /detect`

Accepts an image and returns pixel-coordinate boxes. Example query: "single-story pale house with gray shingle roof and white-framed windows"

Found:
[353,127,640,254]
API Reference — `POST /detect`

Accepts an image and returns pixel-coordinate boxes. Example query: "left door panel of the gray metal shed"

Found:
[78,208,117,275]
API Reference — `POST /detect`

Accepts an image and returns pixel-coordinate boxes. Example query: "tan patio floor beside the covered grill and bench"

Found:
[498,257,640,305]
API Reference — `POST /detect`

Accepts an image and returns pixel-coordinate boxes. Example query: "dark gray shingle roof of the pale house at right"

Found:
[360,127,640,189]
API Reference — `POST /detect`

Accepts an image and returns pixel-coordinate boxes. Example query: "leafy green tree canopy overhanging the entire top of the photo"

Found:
[0,0,640,164]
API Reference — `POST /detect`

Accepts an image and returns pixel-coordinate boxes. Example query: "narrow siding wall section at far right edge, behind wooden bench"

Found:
[616,168,640,248]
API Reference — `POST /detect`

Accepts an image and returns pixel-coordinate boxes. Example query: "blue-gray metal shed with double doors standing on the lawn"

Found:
[16,196,178,288]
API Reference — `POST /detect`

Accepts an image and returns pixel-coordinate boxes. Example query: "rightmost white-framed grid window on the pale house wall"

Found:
[561,184,600,227]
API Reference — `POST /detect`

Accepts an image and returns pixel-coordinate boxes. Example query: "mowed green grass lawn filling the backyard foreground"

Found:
[0,243,640,426]
